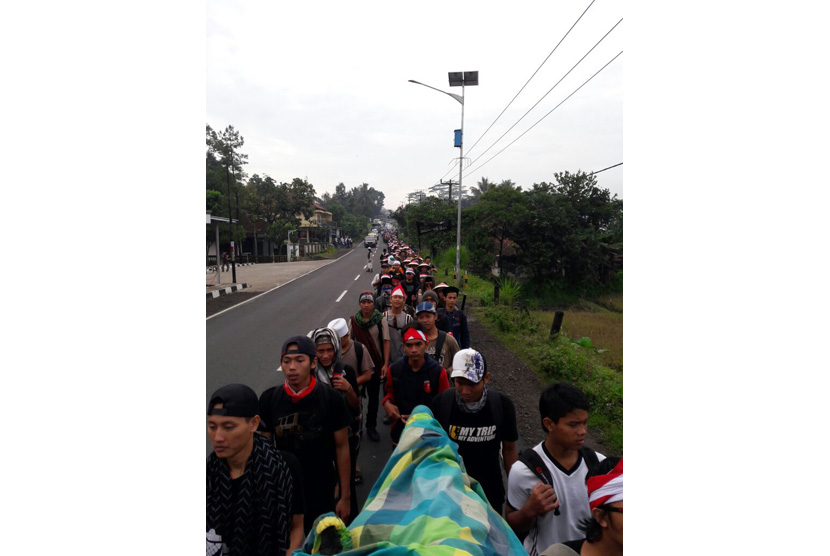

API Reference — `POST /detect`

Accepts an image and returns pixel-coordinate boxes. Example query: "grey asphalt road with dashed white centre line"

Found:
[205,246,392,505]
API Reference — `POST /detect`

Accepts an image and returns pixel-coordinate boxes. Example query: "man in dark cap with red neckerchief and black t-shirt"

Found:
[259,336,352,533]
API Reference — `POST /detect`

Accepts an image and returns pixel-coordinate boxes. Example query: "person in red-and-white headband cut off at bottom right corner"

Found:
[541,458,623,556]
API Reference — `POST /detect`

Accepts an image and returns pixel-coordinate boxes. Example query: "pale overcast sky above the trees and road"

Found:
[206,0,625,210]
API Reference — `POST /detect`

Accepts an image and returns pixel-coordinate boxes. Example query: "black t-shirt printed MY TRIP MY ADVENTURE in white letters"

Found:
[432,388,519,513]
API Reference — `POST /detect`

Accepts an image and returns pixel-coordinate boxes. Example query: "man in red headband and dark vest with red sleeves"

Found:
[383,324,450,445]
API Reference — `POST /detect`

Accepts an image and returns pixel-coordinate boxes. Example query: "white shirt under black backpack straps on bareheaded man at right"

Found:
[507,442,605,556]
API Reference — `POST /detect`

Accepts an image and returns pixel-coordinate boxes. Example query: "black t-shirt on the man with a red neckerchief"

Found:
[259,382,352,521]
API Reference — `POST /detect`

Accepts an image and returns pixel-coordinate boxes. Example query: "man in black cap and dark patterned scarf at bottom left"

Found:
[206,384,304,556]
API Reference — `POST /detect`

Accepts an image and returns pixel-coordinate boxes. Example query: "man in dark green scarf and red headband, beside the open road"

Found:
[349,292,389,442]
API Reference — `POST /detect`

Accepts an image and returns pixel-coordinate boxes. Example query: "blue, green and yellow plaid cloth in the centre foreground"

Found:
[294,405,527,556]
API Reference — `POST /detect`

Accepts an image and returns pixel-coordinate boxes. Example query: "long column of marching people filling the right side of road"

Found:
[206,230,623,556]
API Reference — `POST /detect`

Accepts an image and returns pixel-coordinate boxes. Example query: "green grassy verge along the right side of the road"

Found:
[463,275,623,455]
